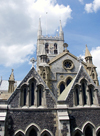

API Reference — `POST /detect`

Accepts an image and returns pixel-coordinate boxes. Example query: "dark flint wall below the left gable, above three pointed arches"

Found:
[6,109,57,136]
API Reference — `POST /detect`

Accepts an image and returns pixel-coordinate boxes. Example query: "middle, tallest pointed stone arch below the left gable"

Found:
[25,123,41,136]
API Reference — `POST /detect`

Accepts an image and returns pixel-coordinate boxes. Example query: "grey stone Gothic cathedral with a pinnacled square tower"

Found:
[0,19,100,136]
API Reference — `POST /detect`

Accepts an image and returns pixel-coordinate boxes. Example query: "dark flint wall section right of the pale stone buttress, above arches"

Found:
[70,108,100,131]
